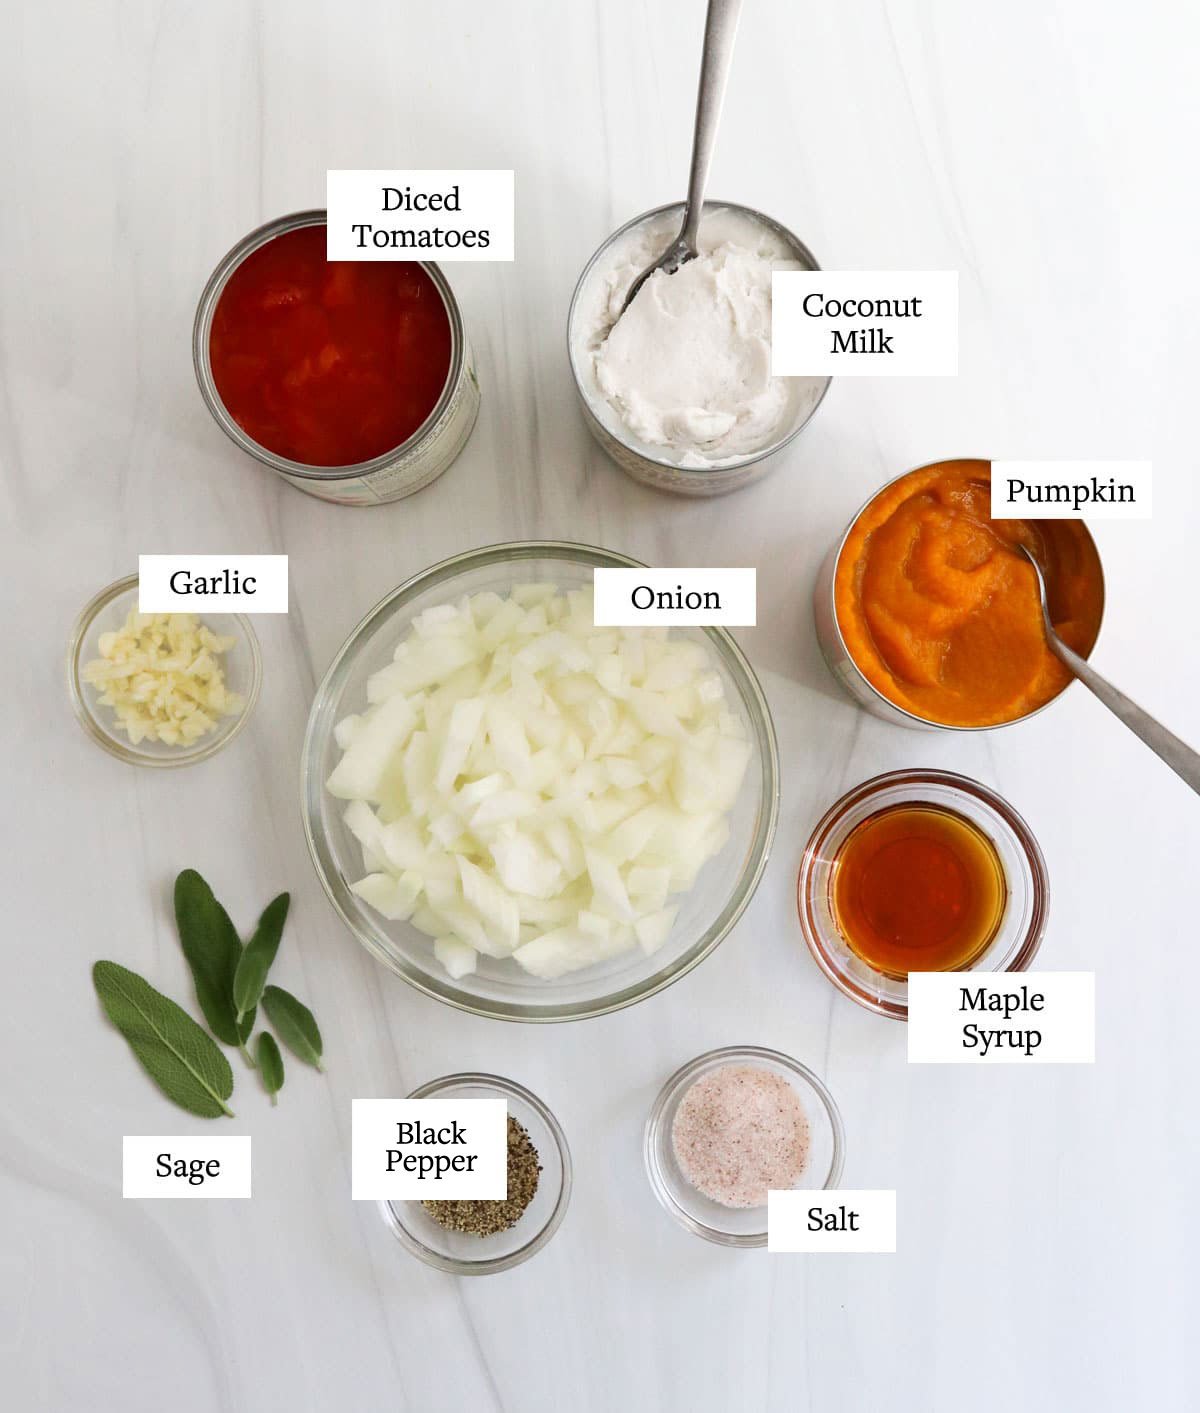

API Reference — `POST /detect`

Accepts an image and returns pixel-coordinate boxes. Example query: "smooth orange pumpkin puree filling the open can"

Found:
[834,461,1104,726]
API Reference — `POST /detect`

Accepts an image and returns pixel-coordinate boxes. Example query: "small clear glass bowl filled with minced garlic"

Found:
[66,574,263,769]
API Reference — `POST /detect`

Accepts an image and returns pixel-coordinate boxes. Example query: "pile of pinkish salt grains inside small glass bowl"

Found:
[671,1064,808,1207]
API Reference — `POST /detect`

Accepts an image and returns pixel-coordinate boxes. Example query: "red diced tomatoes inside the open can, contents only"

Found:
[209,225,451,466]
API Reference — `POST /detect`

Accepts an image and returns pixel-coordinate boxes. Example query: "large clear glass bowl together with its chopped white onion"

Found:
[301,541,779,1022]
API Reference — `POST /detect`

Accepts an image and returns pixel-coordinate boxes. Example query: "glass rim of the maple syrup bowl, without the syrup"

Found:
[796,767,1050,1020]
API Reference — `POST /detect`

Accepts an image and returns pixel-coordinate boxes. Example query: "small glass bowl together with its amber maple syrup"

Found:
[797,770,1050,1020]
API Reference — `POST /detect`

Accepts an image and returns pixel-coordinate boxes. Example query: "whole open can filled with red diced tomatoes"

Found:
[192,211,479,506]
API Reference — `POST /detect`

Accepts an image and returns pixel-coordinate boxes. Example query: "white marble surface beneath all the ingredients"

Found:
[0,0,1200,1413]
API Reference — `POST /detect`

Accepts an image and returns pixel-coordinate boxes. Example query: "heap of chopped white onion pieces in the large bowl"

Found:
[327,584,751,979]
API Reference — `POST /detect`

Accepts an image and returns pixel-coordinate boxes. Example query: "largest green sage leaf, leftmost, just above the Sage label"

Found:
[92,962,233,1119]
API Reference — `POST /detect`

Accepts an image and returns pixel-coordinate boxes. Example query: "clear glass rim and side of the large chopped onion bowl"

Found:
[300,540,780,1024]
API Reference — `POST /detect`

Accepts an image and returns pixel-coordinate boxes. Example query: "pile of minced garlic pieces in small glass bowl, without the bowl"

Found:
[82,609,246,746]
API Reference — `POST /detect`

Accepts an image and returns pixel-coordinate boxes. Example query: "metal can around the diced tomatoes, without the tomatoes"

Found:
[192,211,479,506]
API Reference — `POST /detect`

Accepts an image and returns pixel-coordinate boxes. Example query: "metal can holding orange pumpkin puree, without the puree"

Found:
[813,458,1104,731]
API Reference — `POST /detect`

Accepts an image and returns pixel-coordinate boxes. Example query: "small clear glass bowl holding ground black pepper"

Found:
[379,1074,571,1276]
